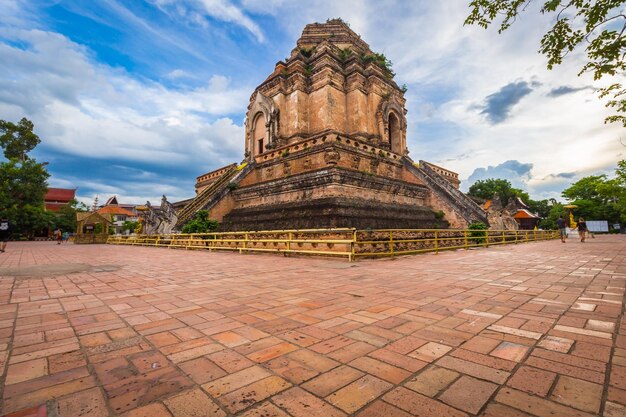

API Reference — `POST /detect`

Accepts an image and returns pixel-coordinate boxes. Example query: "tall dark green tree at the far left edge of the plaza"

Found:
[0,119,55,237]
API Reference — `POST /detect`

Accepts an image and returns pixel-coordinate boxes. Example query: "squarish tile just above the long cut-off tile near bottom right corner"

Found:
[550,376,602,413]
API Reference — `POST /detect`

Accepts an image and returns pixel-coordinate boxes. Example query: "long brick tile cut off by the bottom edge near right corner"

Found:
[495,388,593,417]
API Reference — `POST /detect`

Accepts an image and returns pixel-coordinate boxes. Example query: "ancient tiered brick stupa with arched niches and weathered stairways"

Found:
[173,19,485,230]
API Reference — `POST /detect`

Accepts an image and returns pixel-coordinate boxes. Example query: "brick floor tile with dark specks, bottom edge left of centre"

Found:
[217,376,291,413]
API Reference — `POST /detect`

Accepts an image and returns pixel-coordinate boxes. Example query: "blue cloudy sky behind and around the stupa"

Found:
[0,0,626,203]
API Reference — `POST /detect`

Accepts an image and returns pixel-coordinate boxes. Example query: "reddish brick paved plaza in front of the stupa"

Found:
[0,236,626,417]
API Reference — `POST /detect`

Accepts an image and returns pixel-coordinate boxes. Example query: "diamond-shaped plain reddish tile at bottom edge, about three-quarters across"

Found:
[439,376,498,414]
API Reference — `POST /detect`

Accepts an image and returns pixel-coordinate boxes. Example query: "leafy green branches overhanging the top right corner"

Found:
[465,0,626,127]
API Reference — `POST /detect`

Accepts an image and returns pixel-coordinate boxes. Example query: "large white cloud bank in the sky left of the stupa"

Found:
[0,29,250,165]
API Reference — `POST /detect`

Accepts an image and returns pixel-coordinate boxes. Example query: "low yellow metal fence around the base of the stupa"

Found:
[107,229,559,261]
